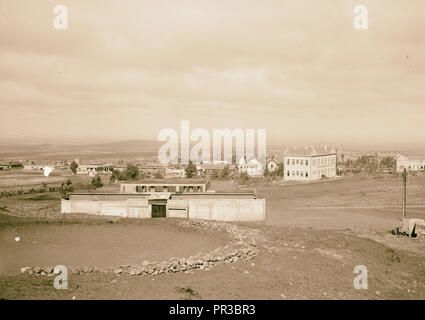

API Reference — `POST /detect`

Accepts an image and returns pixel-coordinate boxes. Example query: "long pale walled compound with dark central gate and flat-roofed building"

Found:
[61,179,266,221]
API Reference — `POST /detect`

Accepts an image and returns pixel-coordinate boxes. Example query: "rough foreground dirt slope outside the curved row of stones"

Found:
[0,215,425,299]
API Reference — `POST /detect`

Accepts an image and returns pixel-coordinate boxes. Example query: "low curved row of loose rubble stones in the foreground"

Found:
[21,220,265,276]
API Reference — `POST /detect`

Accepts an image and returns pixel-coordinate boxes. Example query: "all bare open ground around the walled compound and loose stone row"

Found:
[0,176,425,299]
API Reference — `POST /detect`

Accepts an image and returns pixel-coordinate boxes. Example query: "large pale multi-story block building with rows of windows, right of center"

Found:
[283,146,336,181]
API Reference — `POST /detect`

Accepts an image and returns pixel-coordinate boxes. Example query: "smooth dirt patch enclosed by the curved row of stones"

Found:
[0,220,226,275]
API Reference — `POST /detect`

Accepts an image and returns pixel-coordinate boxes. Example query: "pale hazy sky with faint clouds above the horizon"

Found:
[0,0,425,148]
